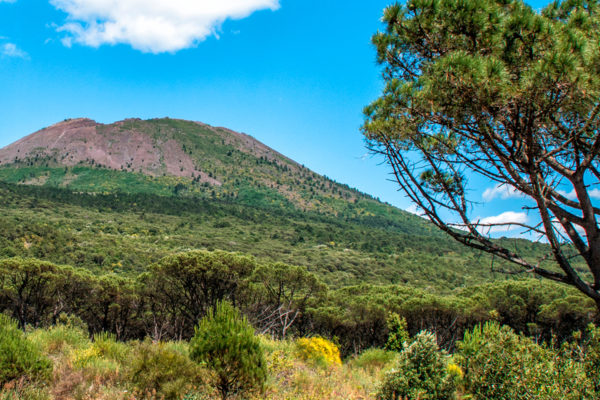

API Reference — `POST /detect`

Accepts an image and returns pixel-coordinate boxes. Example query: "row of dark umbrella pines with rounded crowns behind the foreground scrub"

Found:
[0,250,598,355]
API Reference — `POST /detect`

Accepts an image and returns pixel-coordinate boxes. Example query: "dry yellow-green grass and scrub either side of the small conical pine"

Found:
[0,325,392,400]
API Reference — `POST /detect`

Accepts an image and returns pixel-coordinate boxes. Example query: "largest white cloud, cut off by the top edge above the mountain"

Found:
[50,0,279,53]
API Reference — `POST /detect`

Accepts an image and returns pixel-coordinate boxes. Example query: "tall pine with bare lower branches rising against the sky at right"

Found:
[363,0,600,307]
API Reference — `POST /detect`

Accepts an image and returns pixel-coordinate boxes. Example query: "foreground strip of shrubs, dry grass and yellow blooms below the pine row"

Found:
[0,303,600,400]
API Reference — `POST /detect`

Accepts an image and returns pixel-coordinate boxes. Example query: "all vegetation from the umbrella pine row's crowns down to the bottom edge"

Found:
[0,251,600,400]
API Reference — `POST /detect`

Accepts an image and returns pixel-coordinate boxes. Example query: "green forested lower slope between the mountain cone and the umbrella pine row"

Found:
[0,180,572,291]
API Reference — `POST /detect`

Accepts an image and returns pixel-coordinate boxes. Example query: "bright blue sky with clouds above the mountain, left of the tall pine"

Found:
[0,0,546,234]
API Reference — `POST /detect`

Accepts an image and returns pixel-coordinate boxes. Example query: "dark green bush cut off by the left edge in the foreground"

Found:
[0,314,52,387]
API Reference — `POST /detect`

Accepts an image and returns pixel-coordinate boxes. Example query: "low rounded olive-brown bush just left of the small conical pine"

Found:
[127,340,203,400]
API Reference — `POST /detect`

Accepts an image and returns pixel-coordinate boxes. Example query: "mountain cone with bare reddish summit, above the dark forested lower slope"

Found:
[0,118,437,235]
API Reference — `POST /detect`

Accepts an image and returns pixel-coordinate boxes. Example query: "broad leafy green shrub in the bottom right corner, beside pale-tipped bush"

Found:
[457,323,595,400]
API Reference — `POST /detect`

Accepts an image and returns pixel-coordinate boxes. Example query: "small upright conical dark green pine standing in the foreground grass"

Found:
[190,302,267,399]
